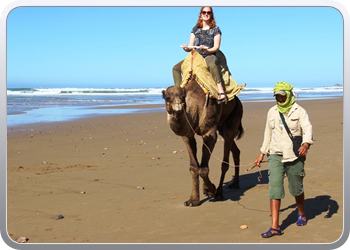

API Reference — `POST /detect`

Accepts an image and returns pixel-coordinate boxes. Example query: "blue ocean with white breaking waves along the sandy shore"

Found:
[7,86,343,127]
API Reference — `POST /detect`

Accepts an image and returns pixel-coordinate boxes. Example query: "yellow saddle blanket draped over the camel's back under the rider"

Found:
[180,50,246,101]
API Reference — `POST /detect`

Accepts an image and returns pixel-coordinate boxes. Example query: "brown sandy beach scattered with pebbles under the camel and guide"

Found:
[7,98,344,243]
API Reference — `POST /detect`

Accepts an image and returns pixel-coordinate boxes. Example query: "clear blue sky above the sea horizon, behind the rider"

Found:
[7,7,343,88]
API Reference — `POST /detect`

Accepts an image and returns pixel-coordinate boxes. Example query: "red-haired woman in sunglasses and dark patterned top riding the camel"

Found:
[173,7,227,102]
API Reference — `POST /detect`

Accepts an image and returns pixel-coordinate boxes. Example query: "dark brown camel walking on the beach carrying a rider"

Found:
[162,75,244,206]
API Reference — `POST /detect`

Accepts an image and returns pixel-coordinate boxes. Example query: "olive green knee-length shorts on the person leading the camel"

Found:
[268,155,305,199]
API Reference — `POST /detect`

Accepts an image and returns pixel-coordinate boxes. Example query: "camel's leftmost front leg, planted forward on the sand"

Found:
[182,135,200,207]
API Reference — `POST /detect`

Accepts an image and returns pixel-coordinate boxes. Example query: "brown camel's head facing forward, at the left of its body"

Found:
[163,85,186,114]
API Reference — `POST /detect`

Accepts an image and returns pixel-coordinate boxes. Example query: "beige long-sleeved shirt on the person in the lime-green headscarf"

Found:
[260,103,313,162]
